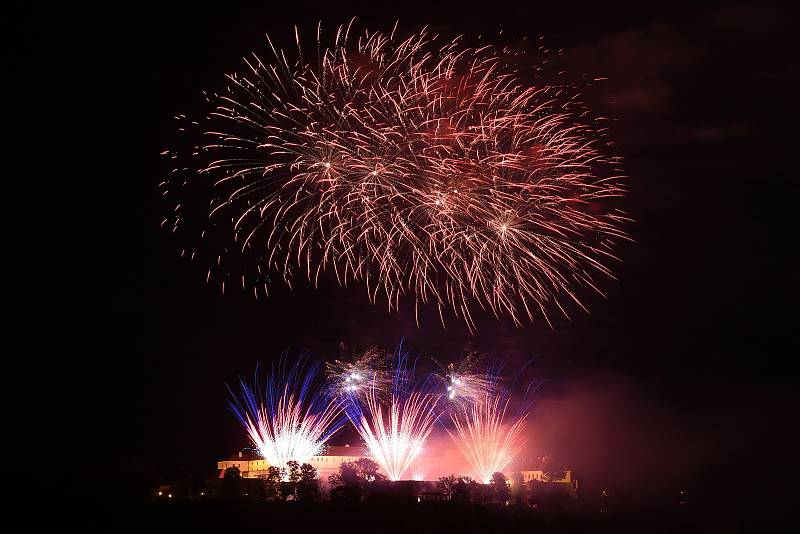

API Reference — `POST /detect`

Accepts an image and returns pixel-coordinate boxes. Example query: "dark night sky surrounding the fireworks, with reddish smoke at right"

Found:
[36,2,800,520]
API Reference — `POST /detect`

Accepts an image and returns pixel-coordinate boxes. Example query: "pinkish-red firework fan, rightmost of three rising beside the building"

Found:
[447,393,528,484]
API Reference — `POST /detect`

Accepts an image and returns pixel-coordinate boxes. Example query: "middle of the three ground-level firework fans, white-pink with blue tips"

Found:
[347,352,441,480]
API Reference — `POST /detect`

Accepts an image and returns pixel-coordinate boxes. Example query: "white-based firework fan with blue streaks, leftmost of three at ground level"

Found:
[228,359,346,467]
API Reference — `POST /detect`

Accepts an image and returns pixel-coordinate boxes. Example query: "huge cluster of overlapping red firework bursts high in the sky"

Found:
[162,22,624,328]
